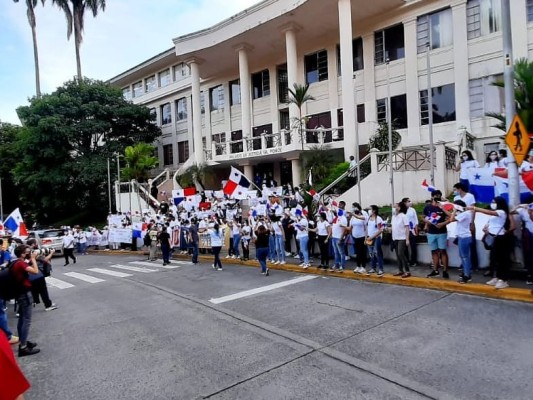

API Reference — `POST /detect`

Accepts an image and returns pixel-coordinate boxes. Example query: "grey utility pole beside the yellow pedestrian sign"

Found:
[501,0,520,207]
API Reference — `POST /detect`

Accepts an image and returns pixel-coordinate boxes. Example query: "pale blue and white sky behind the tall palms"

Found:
[0,0,259,124]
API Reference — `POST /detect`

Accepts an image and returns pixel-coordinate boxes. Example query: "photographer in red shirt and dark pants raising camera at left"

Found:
[8,244,40,357]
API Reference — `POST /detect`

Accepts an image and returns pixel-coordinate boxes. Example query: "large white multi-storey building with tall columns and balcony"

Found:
[111,0,533,197]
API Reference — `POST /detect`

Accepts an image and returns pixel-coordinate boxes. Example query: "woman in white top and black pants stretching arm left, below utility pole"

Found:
[467,196,514,289]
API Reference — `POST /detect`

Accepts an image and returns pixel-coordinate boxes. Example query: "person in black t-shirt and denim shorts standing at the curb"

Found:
[424,190,450,279]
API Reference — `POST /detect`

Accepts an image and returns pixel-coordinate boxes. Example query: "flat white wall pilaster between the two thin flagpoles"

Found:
[403,19,422,145]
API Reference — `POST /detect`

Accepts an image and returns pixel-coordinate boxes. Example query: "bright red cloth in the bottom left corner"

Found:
[0,334,30,400]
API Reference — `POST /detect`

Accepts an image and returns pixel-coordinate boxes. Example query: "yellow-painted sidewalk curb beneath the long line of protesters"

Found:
[89,250,533,303]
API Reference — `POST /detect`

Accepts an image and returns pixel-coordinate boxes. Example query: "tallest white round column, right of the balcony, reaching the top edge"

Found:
[338,0,359,161]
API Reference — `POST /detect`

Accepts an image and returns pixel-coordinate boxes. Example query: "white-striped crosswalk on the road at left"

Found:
[46,261,181,290]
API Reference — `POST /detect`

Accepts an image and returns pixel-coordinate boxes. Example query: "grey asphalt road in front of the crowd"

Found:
[10,255,533,400]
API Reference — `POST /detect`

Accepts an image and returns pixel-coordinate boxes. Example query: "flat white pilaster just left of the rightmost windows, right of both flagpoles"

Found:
[452,2,470,130]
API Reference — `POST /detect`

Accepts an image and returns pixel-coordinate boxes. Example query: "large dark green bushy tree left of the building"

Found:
[14,79,161,220]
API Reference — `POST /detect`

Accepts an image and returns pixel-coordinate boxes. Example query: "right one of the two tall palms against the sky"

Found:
[52,0,105,80]
